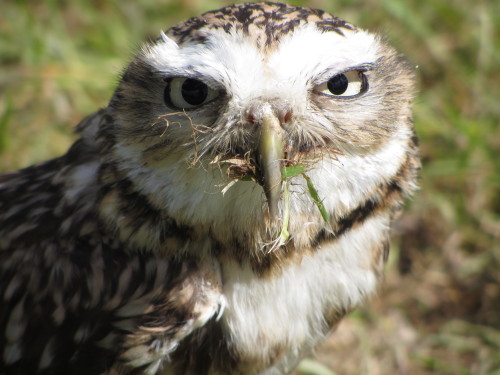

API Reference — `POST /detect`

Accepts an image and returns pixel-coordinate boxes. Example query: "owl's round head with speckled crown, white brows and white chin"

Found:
[105,4,412,253]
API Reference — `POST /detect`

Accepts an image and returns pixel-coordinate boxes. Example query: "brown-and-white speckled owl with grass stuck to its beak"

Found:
[0,3,419,375]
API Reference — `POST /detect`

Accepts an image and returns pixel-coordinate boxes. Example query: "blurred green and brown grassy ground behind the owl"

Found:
[0,0,500,375]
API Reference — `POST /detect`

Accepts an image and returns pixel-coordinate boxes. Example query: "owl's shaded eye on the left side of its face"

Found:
[165,77,218,109]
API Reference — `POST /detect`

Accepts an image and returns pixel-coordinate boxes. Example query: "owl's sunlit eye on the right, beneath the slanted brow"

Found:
[315,70,367,97]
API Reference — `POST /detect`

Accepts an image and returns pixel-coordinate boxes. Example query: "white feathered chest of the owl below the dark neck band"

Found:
[222,216,381,374]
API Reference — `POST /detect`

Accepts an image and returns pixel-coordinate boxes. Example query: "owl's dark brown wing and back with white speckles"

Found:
[0,116,220,374]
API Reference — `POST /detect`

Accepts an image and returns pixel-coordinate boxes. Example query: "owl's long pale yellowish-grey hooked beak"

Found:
[257,111,284,223]
